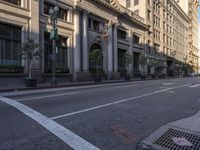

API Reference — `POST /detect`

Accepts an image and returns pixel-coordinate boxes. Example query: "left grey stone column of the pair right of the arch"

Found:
[108,24,113,79]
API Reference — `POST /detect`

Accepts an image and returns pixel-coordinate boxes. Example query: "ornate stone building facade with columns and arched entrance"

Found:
[0,0,148,81]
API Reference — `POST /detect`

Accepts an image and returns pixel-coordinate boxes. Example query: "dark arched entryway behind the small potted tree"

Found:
[89,43,104,74]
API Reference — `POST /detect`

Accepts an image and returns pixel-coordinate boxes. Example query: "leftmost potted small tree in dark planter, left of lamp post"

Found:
[18,38,40,87]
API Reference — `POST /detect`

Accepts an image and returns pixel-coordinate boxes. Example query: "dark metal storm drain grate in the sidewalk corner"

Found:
[154,128,200,150]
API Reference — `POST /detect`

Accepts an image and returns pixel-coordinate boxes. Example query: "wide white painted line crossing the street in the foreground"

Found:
[0,96,100,150]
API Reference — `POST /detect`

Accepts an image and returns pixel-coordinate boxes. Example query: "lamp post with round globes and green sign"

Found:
[49,6,59,85]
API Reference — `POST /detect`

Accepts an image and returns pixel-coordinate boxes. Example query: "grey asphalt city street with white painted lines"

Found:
[0,77,200,150]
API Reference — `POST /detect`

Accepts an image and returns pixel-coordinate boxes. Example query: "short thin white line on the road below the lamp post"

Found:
[16,92,78,102]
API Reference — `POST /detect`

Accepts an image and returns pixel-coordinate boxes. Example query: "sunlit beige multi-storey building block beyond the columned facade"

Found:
[119,0,198,75]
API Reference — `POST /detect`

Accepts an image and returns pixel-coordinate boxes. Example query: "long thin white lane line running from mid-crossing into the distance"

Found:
[51,83,191,120]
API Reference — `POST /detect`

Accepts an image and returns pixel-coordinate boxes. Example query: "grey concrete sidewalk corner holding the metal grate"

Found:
[137,111,200,150]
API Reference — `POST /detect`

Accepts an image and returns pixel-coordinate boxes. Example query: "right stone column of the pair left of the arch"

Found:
[82,11,89,72]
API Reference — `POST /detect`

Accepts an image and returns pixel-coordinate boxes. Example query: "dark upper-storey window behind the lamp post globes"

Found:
[44,2,68,21]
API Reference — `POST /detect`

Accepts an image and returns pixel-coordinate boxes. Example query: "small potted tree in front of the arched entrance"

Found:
[89,49,103,82]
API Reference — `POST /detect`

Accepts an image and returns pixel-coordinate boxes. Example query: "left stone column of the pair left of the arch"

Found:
[73,10,81,81]
